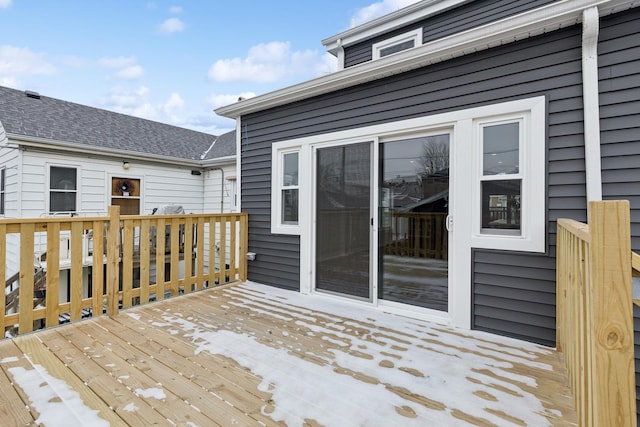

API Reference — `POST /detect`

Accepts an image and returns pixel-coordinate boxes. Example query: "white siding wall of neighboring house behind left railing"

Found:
[0,148,236,277]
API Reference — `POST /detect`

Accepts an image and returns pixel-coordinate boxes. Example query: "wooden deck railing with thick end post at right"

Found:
[557,201,640,427]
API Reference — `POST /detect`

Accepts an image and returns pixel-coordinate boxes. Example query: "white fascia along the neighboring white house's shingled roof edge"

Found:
[7,133,202,167]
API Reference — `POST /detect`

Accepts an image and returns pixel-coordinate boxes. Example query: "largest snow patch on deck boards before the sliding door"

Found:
[158,283,551,426]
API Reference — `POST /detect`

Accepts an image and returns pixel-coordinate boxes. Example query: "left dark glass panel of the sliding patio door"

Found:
[315,143,371,299]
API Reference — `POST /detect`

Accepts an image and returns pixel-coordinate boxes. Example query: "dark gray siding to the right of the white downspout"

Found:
[598,8,640,252]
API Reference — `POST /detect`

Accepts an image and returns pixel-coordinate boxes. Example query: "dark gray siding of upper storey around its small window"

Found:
[345,0,555,68]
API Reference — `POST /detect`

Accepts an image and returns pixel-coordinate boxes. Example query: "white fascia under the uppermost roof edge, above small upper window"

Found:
[322,0,469,55]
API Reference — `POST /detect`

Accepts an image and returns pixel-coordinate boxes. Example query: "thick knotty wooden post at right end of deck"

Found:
[586,201,636,426]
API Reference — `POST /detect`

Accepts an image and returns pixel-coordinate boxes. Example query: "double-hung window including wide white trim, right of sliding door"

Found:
[469,98,546,252]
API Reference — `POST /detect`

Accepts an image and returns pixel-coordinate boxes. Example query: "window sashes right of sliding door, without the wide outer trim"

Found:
[480,121,522,235]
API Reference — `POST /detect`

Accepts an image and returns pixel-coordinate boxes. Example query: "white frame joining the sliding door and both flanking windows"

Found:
[271,96,547,329]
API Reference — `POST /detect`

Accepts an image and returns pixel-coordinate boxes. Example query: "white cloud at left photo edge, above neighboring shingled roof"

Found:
[0,45,56,87]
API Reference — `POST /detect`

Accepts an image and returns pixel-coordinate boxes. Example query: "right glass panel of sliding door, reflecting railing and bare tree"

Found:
[378,134,450,311]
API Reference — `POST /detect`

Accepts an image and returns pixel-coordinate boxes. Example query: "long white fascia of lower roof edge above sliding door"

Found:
[215,0,640,118]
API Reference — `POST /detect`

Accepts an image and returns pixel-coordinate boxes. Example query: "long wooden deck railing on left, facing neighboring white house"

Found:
[0,206,247,338]
